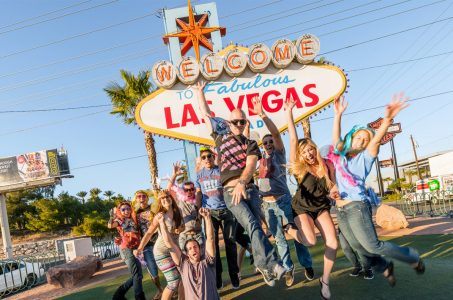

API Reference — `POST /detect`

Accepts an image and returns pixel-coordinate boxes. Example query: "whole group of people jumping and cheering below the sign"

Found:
[108,82,425,300]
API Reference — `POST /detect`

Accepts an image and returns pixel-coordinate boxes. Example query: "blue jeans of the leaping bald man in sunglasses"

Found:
[223,185,278,272]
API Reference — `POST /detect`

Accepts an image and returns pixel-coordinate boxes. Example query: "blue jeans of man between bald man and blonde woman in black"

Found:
[262,195,294,271]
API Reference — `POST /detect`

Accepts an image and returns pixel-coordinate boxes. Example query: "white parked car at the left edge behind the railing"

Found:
[0,260,44,292]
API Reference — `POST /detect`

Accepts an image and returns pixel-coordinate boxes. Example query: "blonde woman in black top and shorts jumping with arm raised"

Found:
[285,99,338,299]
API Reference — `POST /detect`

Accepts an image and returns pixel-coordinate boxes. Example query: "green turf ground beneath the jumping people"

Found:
[60,235,453,300]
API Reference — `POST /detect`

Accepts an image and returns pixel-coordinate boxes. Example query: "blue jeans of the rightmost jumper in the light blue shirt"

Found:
[337,201,420,273]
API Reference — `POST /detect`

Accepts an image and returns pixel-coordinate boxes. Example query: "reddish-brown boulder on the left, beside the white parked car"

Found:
[46,255,102,287]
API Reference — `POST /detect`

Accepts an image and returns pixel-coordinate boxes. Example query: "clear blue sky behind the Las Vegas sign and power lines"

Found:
[0,0,453,196]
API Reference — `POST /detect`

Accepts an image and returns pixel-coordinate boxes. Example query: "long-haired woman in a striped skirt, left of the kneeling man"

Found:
[134,190,184,300]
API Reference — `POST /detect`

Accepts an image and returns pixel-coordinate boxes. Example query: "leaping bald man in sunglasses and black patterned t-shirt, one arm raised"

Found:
[196,82,286,286]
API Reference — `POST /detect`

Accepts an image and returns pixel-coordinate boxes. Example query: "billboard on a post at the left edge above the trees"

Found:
[0,149,69,187]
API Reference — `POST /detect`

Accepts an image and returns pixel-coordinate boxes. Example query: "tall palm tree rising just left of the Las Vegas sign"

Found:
[104,70,158,189]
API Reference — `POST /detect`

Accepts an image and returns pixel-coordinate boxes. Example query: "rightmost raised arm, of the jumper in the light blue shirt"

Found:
[367,93,409,157]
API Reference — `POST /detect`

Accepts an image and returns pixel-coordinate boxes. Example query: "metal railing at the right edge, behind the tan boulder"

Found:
[397,191,453,217]
